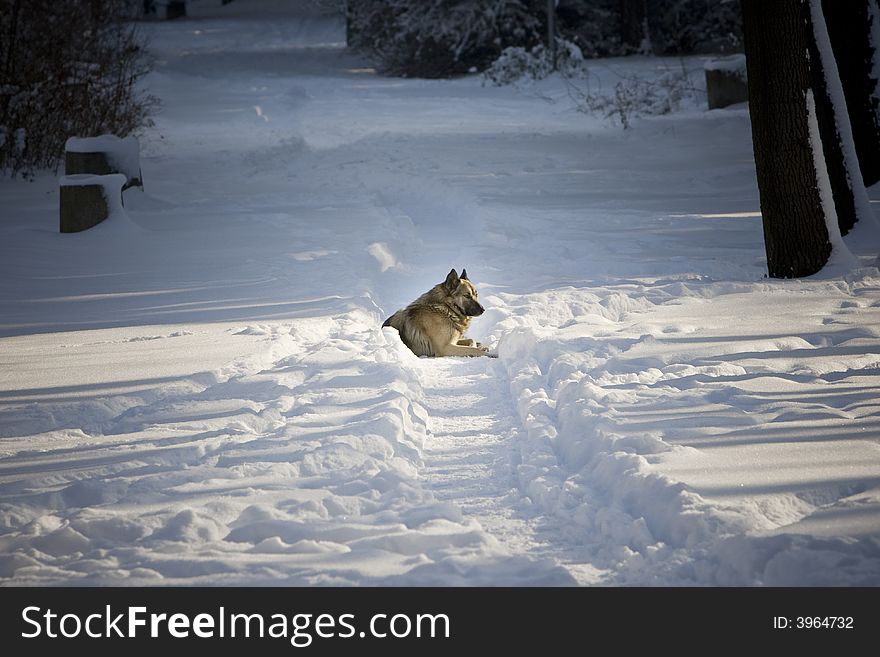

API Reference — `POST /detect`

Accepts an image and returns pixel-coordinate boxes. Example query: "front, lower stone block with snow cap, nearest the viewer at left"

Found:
[61,173,127,233]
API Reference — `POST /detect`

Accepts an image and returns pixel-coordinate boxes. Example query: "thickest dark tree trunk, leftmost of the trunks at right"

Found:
[741,0,831,278]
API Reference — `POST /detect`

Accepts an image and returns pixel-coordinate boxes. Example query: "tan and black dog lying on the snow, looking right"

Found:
[382,268,489,357]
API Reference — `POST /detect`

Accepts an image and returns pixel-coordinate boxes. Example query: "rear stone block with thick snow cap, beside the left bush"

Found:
[64,135,144,189]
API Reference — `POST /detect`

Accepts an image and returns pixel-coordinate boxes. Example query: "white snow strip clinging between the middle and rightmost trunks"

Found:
[809,0,873,234]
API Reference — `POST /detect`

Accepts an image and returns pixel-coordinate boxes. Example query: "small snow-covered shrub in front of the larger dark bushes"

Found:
[483,39,586,86]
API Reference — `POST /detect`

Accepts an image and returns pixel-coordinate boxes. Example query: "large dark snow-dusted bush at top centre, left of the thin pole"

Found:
[346,0,546,78]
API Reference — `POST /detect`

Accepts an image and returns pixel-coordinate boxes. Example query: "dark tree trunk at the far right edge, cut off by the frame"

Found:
[822,0,880,186]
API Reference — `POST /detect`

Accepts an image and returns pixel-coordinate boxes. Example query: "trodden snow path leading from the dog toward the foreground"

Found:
[417,358,603,585]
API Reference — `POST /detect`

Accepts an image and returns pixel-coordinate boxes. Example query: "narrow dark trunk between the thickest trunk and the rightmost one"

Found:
[804,0,867,235]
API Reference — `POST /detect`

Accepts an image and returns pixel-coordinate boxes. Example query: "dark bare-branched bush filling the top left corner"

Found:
[0,0,154,175]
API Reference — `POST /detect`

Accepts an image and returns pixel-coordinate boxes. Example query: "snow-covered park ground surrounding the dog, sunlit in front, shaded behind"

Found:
[0,0,880,585]
